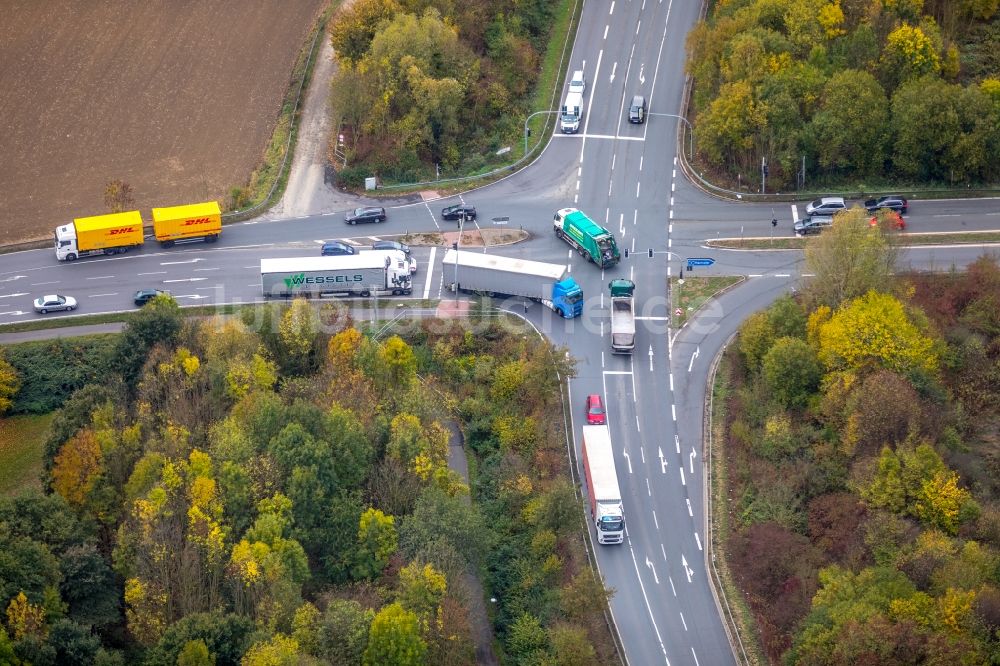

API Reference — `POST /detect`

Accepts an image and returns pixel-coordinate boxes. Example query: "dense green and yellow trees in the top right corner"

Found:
[688,0,1000,191]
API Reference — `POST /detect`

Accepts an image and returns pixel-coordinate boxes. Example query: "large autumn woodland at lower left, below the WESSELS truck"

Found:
[0,296,611,666]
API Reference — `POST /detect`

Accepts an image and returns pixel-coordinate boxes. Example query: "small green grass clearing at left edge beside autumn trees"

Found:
[0,413,54,496]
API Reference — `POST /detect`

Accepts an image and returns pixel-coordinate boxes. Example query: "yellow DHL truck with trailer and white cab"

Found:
[55,201,222,261]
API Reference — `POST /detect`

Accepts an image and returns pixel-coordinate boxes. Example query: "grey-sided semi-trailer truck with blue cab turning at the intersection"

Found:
[442,250,583,319]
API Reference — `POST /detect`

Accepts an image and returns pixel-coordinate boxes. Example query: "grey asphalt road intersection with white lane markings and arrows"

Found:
[0,0,1000,666]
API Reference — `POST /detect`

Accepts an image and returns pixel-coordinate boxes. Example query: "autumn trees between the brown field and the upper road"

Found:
[331,0,555,181]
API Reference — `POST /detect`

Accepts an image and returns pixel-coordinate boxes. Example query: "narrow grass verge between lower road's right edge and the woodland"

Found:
[709,356,768,666]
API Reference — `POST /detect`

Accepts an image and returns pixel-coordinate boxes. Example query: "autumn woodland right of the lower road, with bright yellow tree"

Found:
[726,211,1000,666]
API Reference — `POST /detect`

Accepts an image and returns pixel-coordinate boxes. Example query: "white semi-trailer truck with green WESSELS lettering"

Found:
[260,251,412,298]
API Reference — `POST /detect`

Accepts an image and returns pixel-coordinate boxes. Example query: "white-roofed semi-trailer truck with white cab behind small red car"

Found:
[583,425,625,544]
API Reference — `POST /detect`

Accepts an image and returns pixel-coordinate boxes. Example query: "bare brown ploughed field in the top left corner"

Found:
[0,0,329,244]
